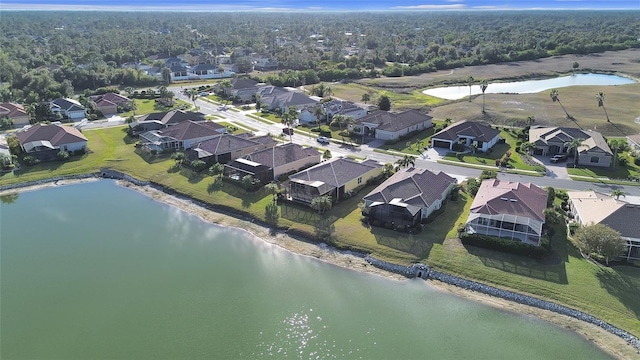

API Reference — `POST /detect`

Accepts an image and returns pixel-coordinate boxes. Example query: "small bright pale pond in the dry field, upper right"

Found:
[422,74,635,100]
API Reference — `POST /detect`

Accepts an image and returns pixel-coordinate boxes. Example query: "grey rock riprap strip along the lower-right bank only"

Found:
[365,256,640,352]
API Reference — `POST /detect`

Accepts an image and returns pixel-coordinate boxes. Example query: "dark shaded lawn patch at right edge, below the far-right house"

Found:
[596,266,640,318]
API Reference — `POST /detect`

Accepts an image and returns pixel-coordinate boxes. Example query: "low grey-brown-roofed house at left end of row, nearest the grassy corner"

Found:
[140,120,227,152]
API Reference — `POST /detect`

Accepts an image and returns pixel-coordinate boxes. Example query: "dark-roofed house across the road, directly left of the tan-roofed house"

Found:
[431,120,500,152]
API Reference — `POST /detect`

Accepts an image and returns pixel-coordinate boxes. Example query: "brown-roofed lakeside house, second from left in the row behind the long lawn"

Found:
[185,134,276,165]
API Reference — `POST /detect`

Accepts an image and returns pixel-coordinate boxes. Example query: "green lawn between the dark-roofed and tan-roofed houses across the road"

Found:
[445,130,542,171]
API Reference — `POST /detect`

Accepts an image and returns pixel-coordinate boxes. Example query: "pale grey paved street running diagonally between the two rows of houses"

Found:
[170,87,640,196]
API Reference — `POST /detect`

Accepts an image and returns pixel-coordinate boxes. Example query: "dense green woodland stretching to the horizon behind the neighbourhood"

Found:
[0,11,640,103]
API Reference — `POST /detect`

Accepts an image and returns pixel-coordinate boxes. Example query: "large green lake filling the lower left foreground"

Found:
[0,181,608,359]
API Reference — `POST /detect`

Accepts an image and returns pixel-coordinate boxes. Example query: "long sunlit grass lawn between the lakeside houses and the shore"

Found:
[0,127,640,335]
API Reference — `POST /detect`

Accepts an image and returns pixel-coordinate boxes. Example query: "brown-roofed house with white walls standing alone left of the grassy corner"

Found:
[15,124,88,161]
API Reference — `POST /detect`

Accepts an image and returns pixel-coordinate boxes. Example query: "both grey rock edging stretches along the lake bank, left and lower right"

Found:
[0,173,640,352]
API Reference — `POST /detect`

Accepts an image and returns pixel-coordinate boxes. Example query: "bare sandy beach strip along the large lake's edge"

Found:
[0,178,640,359]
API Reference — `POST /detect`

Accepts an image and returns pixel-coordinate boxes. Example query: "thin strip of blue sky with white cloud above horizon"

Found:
[0,0,640,11]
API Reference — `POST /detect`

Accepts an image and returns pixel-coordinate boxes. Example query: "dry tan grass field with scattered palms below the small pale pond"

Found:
[430,84,640,137]
